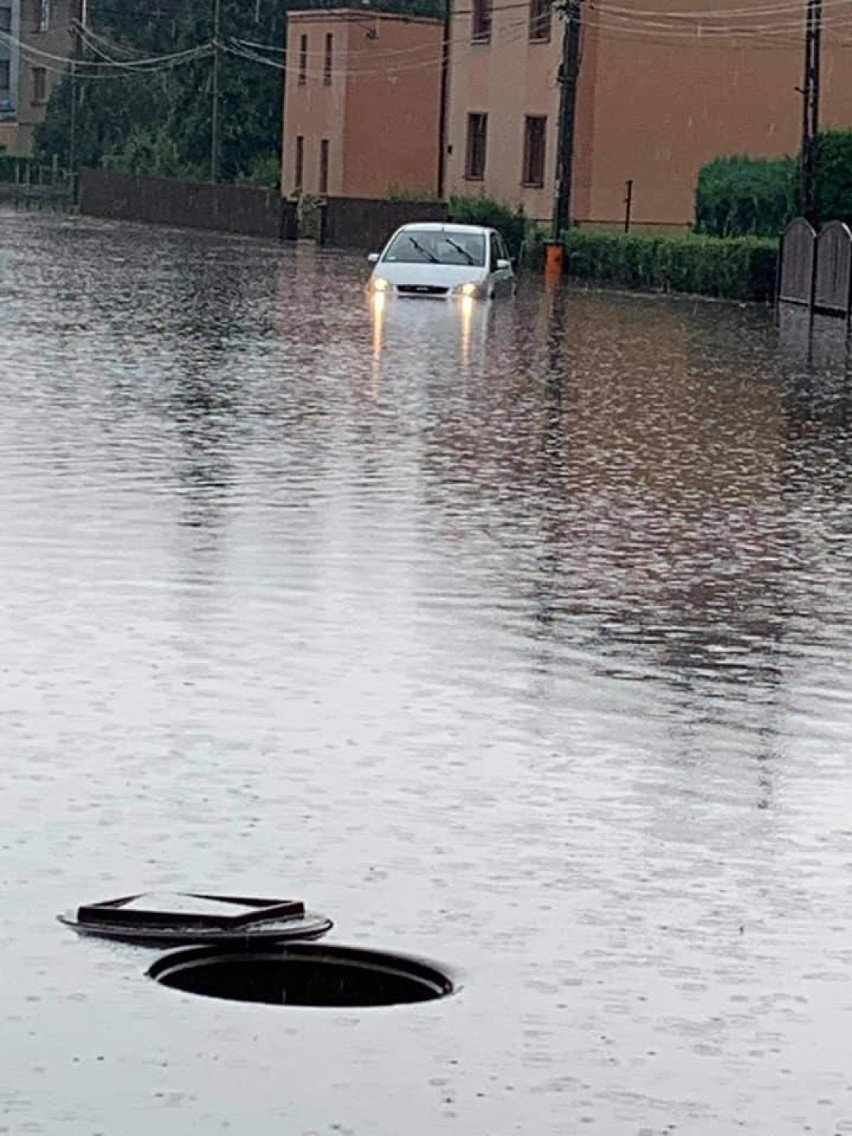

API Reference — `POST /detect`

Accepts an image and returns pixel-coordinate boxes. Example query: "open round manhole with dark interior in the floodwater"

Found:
[148,943,453,1006]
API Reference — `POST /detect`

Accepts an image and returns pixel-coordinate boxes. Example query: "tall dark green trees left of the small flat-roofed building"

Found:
[35,0,441,184]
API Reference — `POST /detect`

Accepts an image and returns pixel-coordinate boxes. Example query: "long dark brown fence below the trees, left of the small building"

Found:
[80,169,295,240]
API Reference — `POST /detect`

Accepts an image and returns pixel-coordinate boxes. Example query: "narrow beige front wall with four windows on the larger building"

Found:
[446,0,561,220]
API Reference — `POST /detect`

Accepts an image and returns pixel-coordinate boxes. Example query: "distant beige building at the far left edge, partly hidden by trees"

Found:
[0,0,74,154]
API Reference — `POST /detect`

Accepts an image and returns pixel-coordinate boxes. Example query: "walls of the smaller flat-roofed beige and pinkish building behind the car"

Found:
[282,9,443,198]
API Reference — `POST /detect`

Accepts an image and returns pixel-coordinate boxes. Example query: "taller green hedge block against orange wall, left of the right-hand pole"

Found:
[695,157,799,236]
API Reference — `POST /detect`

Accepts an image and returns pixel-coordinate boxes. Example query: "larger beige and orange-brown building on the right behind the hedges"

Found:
[446,0,852,225]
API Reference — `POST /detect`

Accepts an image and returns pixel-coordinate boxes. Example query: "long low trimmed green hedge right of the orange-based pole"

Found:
[565,228,778,300]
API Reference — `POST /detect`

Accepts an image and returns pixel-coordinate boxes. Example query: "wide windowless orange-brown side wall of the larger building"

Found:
[575,8,852,224]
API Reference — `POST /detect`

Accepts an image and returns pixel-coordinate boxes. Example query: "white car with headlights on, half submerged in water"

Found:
[368,222,515,300]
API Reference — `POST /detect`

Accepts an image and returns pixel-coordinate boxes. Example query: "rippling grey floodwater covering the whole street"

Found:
[0,212,852,1136]
